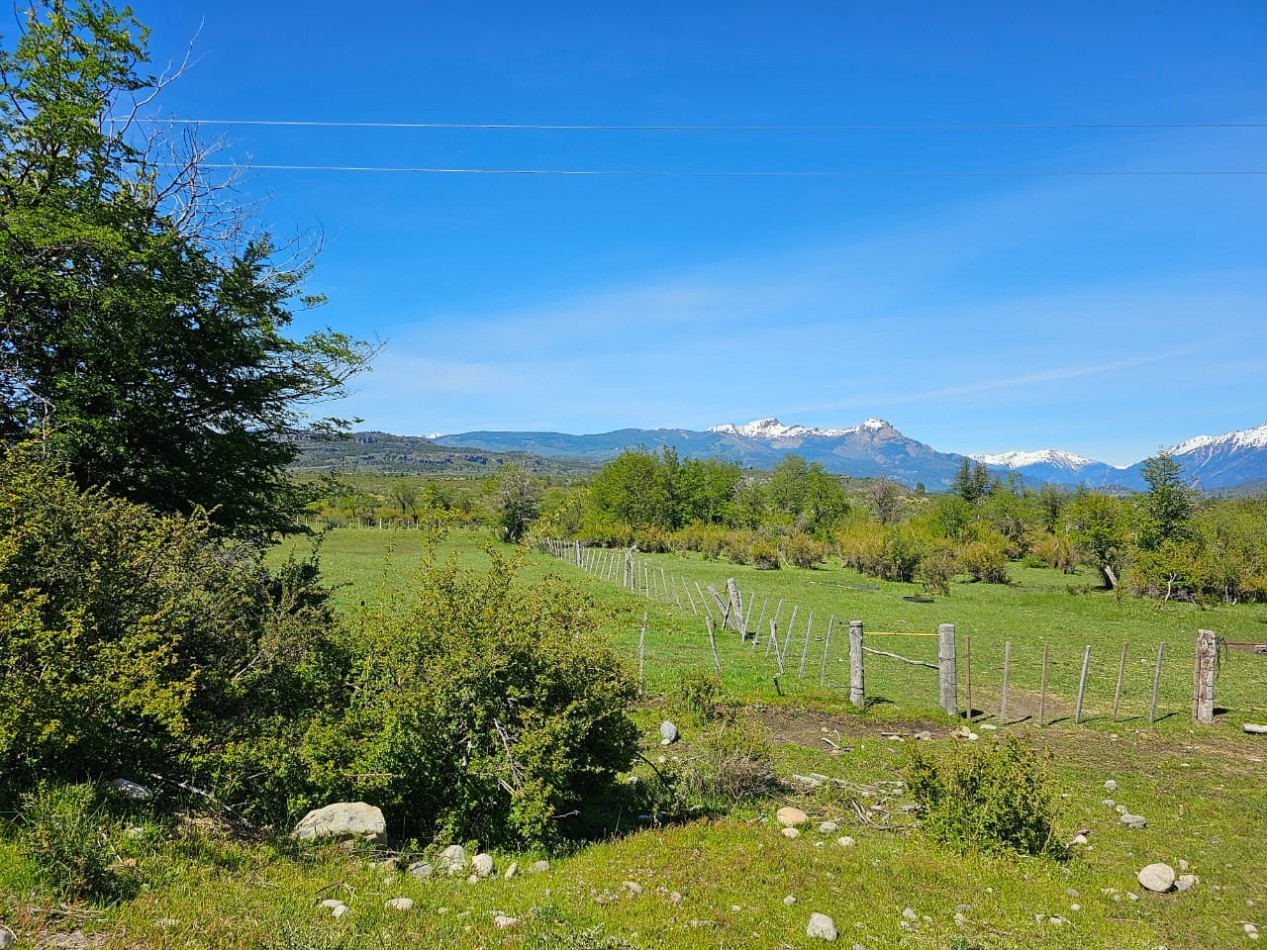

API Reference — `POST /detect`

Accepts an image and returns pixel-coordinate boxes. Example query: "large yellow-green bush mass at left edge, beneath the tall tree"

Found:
[0,450,338,802]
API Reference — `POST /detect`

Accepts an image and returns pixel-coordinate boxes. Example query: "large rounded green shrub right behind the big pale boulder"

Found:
[312,548,637,845]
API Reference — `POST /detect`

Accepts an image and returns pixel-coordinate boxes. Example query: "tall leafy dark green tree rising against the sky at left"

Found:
[0,0,370,536]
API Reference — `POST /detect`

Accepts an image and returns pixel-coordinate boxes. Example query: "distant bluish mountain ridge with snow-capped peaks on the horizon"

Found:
[433,417,1267,490]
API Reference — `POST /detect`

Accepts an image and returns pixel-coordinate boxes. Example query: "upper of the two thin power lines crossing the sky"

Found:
[134,117,1267,132]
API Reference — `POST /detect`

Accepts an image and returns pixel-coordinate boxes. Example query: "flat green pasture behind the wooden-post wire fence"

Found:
[285,528,1267,728]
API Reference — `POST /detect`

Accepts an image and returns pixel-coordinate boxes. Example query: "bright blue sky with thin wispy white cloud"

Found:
[134,0,1267,464]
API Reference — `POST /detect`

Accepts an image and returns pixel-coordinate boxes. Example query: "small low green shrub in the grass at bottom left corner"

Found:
[19,783,134,901]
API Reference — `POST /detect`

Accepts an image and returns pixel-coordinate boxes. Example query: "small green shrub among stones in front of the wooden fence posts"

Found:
[906,737,1063,856]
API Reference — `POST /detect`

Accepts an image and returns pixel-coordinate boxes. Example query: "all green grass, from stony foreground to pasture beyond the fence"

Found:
[0,529,1267,950]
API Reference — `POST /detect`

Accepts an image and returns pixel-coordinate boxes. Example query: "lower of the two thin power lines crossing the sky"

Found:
[181,162,1267,179]
